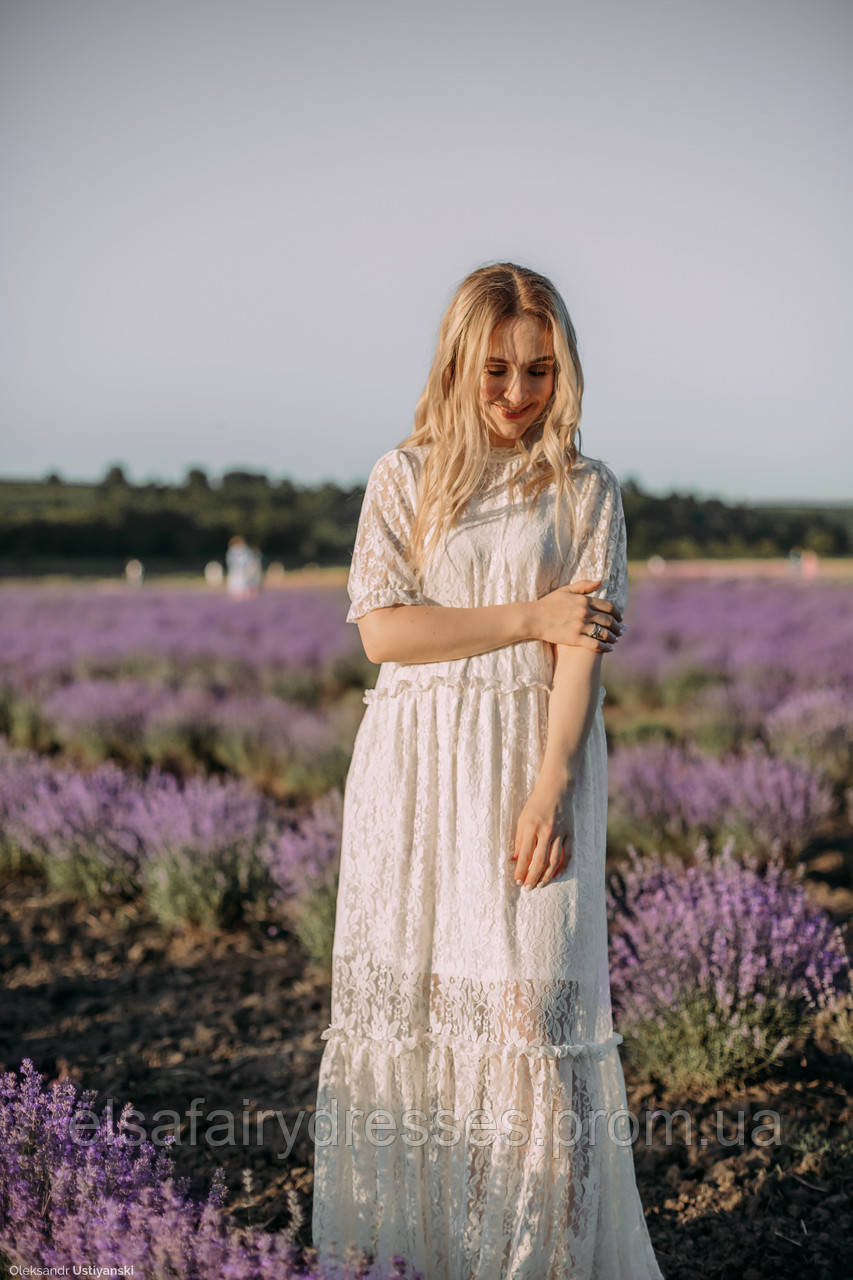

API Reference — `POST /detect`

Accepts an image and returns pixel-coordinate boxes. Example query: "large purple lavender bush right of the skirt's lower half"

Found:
[607,844,850,1091]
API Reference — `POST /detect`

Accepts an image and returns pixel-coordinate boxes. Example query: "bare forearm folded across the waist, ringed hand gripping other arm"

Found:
[357,581,622,663]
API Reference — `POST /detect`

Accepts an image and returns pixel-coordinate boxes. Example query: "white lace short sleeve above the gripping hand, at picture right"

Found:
[569,462,628,613]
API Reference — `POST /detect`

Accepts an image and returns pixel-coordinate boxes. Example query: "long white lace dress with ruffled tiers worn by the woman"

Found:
[313,445,661,1280]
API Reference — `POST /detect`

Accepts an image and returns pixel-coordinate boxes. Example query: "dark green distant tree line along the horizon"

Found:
[0,466,853,573]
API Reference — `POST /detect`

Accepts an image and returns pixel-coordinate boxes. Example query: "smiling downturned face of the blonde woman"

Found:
[480,315,555,448]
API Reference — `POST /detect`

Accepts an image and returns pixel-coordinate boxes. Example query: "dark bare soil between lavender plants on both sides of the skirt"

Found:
[0,850,853,1280]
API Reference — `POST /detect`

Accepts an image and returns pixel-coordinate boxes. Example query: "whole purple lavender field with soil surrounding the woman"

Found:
[0,575,853,1280]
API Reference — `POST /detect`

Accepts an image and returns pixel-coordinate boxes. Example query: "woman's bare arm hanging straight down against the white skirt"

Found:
[510,645,602,888]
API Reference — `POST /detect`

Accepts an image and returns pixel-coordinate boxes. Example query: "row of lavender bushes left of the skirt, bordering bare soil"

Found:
[0,740,339,928]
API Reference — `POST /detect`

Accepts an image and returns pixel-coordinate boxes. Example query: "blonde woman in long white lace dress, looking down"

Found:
[313,264,661,1280]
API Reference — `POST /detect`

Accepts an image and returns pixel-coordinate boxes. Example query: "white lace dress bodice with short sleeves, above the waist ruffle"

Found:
[347,445,628,701]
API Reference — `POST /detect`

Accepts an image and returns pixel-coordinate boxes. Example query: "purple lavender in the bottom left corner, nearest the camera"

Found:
[0,1059,423,1280]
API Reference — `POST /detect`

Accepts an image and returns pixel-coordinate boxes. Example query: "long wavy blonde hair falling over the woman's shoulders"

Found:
[398,262,584,572]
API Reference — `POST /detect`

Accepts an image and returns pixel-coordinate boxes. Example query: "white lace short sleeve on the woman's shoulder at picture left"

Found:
[346,449,427,622]
